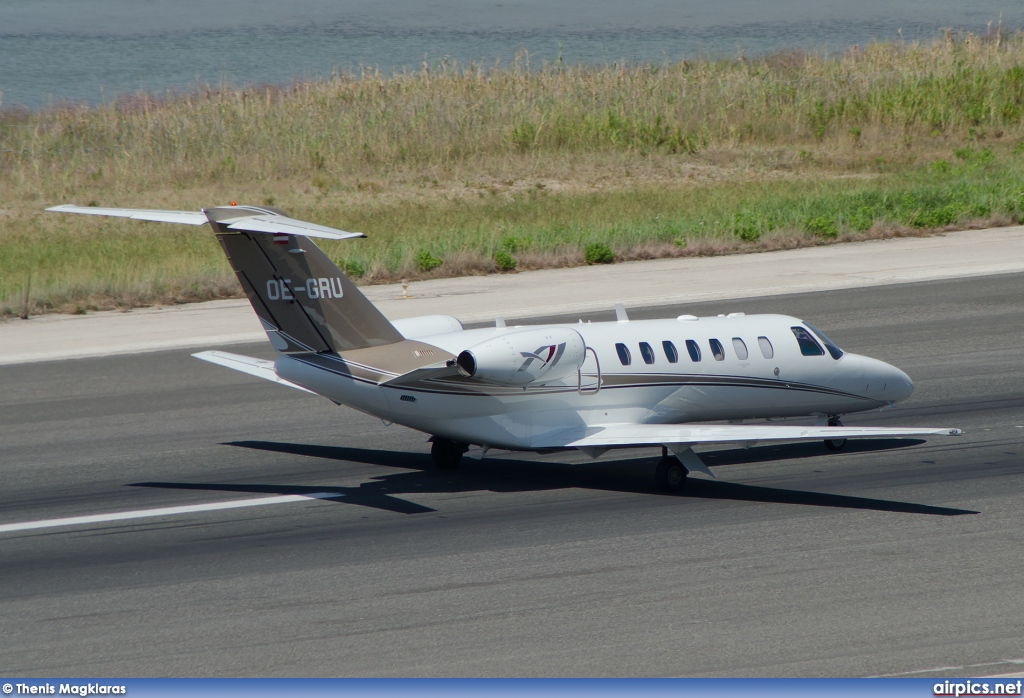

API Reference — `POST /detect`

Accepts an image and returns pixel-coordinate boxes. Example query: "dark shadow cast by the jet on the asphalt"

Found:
[133,439,978,516]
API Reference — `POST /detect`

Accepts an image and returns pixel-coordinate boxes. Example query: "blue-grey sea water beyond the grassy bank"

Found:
[0,0,1024,110]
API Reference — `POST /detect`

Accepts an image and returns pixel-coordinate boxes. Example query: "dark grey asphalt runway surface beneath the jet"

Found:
[0,275,1024,677]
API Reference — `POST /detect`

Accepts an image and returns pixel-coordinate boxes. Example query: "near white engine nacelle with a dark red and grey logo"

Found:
[456,328,587,386]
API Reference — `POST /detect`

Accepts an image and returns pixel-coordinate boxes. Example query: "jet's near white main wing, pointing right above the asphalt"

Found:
[531,424,962,448]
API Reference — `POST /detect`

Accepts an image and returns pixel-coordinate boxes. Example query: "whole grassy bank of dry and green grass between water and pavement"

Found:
[0,35,1024,314]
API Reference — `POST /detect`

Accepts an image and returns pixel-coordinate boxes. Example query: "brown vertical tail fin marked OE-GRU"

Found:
[217,227,403,352]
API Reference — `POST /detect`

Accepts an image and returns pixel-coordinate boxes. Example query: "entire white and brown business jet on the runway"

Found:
[48,205,959,491]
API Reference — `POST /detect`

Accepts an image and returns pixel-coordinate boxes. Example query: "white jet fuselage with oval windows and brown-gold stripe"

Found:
[276,315,913,448]
